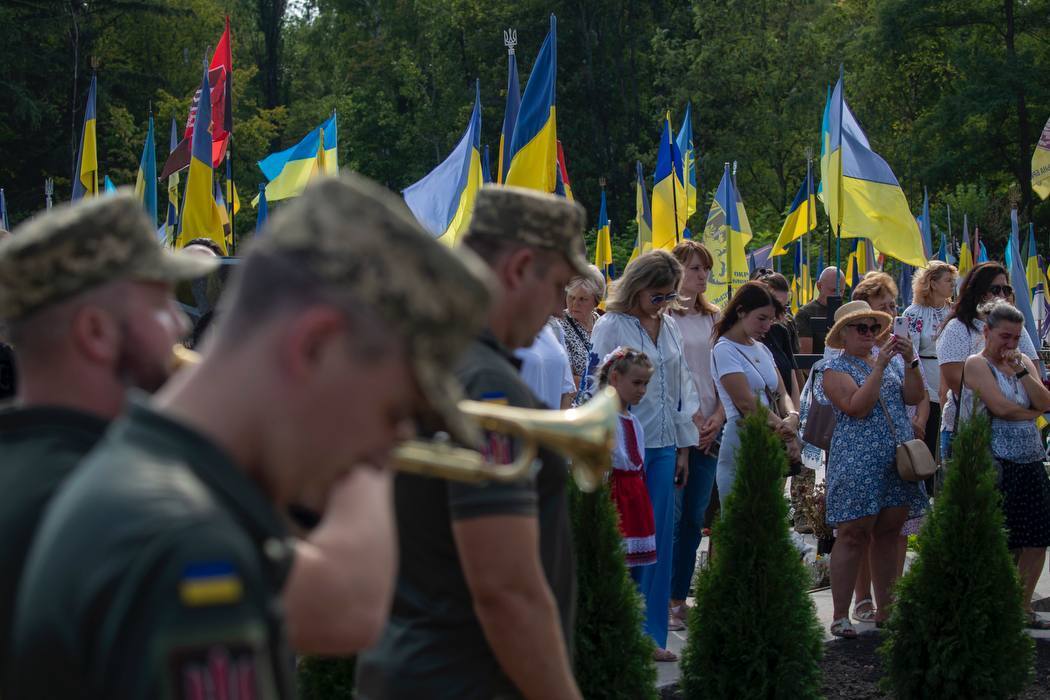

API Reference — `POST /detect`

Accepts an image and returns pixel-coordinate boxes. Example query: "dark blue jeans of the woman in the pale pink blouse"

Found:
[671,447,718,600]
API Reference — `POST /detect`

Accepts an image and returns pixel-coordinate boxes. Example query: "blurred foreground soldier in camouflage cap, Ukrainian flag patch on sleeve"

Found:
[12,171,489,698]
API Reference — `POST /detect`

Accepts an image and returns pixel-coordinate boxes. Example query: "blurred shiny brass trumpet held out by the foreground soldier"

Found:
[391,388,620,492]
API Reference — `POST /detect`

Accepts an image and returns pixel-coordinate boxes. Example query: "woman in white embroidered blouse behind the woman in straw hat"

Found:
[904,260,959,465]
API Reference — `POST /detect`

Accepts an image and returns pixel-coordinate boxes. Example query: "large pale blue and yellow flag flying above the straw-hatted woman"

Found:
[820,71,926,267]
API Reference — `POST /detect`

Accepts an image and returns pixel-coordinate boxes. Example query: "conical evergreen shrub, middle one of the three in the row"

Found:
[681,412,823,700]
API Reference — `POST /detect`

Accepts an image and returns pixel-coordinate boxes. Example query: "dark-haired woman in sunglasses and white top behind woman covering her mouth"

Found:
[937,262,1042,461]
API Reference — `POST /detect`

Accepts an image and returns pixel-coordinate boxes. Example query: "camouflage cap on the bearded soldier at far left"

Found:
[0,189,218,321]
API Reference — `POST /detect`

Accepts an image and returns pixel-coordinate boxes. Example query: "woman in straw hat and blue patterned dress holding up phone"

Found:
[823,301,927,638]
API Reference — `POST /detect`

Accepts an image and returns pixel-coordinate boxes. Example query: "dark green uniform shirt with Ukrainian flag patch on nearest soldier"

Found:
[13,403,293,699]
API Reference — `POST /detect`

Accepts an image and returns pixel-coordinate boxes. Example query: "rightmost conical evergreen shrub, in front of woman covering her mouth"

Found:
[880,417,1032,700]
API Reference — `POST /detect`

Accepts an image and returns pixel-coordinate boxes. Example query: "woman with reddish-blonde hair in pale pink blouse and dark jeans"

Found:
[668,238,726,630]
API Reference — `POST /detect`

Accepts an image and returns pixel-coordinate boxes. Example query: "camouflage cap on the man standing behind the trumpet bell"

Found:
[466,185,589,275]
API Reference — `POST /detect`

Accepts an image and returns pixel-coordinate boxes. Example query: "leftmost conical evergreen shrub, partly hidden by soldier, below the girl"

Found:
[569,483,657,700]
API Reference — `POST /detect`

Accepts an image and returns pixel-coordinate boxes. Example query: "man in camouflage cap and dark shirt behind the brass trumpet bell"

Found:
[357,187,589,700]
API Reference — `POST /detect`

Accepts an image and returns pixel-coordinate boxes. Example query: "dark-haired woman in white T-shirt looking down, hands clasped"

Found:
[711,281,799,503]
